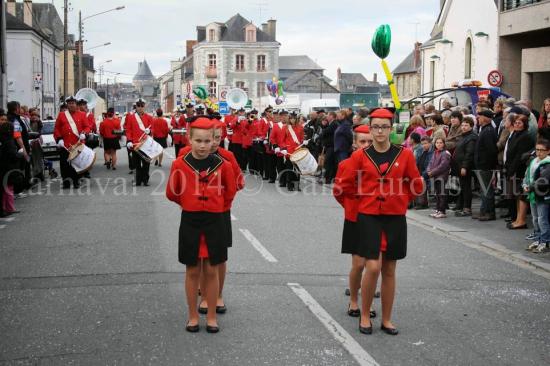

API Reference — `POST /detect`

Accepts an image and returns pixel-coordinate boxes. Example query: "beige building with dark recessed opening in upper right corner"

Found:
[498,0,550,109]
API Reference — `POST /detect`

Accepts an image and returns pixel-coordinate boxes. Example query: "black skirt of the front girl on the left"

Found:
[178,211,227,266]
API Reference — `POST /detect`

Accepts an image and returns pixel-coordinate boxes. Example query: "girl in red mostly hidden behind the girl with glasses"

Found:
[332,125,376,318]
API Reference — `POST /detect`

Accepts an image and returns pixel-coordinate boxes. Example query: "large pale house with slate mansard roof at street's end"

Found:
[193,14,280,105]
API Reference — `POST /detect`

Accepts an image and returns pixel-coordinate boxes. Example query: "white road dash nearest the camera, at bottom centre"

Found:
[287,283,378,366]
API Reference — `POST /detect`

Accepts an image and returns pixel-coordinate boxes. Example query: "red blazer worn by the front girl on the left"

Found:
[166,151,237,213]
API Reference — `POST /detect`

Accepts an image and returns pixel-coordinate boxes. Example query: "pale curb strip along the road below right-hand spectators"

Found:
[407,211,550,274]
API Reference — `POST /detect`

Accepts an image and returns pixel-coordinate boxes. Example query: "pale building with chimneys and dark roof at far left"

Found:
[6,2,61,117]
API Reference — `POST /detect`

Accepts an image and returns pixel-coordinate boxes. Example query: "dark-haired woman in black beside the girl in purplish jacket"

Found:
[453,116,477,217]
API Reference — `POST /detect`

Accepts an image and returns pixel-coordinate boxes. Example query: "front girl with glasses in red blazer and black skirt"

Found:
[339,108,424,335]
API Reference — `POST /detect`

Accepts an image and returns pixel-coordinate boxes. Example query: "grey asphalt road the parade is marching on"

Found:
[0,150,550,365]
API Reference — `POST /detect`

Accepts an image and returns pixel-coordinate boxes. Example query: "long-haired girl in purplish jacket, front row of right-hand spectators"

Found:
[427,137,451,219]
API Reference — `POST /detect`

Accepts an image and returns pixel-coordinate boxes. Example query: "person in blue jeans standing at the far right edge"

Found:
[523,139,550,253]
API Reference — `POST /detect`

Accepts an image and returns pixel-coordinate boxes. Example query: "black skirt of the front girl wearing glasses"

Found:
[356,214,407,260]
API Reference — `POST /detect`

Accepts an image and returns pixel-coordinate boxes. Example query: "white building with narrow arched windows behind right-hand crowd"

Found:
[421,0,498,93]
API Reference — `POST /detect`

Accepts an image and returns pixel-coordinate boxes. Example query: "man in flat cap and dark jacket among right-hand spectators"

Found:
[472,109,498,221]
